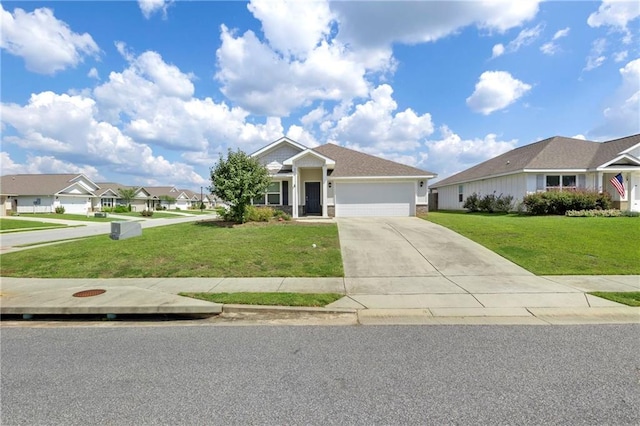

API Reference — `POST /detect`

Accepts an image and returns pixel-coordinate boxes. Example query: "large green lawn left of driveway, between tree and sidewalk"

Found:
[1,221,343,278]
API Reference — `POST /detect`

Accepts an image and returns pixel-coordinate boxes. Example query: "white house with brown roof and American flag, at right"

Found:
[431,134,640,211]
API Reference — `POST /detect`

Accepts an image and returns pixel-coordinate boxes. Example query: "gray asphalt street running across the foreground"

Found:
[0,325,640,425]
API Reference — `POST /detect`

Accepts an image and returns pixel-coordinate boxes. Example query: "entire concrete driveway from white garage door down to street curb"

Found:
[336,217,600,308]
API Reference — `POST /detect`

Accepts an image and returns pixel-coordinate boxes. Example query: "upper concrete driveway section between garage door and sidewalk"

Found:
[336,217,532,278]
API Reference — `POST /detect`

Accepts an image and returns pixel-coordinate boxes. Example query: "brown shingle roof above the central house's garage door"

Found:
[313,143,436,178]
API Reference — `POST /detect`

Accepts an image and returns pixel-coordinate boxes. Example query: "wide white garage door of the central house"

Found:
[334,182,416,217]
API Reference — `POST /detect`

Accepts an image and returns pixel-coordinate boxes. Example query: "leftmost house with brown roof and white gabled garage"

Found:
[0,173,100,216]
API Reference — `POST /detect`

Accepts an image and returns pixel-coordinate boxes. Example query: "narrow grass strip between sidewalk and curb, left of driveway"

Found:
[180,292,344,307]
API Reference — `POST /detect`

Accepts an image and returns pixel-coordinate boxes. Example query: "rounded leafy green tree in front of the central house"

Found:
[211,149,271,223]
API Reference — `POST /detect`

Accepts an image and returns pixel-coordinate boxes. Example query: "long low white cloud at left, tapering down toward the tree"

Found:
[2,92,206,185]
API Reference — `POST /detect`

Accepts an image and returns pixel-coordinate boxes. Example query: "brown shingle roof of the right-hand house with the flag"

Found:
[431,135,640,188]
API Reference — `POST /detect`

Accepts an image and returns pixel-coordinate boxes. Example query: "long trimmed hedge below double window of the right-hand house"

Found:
[522,191,612,215]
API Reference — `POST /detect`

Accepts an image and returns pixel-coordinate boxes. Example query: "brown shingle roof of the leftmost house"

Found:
[0,173,96,195]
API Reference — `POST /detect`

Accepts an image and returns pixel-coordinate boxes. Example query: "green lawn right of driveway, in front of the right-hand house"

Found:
[425,212,640,275]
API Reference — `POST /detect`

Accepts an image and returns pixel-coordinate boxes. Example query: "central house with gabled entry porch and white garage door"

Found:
[251,137,436,218]
